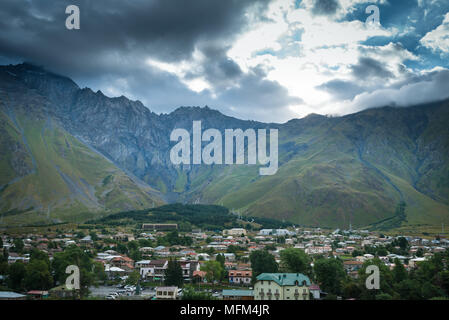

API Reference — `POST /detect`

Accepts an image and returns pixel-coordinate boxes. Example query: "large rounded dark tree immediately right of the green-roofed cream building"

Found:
[313,258,346,295]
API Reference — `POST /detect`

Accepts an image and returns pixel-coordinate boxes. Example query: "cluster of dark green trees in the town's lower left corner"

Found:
[0,246,106,296]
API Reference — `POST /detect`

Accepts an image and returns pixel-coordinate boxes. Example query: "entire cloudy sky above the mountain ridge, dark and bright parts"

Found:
[0,0,449,122]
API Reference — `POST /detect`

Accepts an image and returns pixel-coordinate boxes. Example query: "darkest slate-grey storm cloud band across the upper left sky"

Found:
[0,0,267,72]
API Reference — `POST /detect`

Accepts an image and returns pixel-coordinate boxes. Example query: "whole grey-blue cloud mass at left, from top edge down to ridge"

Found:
[0,0,300,120]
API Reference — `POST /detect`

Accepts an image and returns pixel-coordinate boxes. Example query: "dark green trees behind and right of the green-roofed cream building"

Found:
[250,248,449,300]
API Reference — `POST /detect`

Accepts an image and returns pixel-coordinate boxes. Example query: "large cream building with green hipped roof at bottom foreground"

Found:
[254,273,311,300]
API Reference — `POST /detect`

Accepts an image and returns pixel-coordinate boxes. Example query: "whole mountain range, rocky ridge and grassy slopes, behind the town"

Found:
[0,63,449,228]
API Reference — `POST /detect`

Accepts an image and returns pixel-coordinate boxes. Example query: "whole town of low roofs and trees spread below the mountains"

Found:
[0,205,449,300]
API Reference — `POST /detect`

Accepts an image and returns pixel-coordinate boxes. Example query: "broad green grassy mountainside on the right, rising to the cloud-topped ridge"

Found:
[180,102,449,228]
